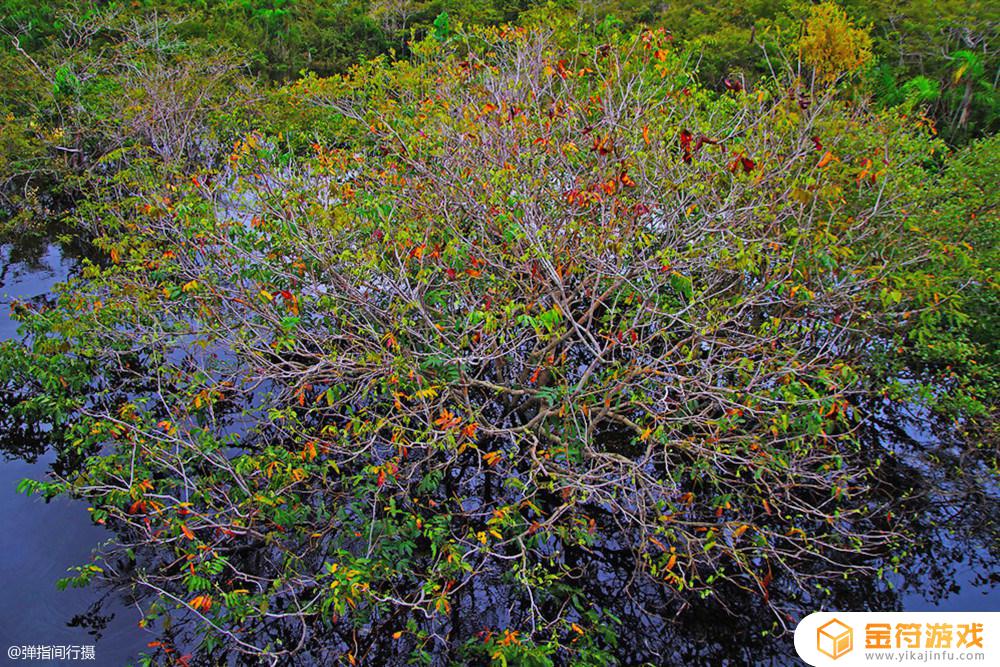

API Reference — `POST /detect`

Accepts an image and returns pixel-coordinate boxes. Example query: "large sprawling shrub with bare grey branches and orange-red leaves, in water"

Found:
[3,20,992,664]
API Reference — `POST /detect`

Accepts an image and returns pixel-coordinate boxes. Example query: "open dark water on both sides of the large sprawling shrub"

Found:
[0,240,1000,665]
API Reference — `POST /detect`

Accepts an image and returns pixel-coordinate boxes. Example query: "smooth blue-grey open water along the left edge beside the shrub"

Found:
[0,242,152,665]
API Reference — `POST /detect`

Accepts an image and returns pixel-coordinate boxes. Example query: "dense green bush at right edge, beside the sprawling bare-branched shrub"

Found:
[893,137,1000,418]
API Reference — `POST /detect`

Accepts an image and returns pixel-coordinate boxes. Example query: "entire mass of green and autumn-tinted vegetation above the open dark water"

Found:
[0,0,1000,665]
